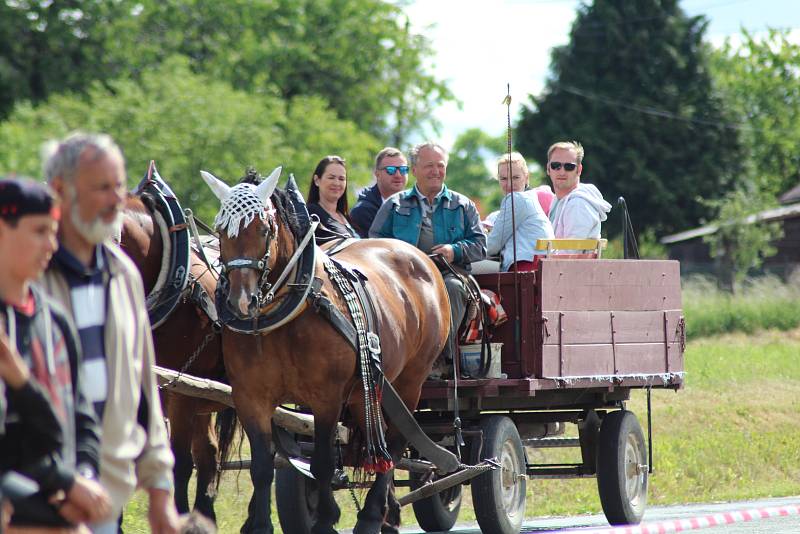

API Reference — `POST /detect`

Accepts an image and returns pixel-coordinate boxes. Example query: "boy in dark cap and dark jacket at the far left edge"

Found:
[0,179,110,532]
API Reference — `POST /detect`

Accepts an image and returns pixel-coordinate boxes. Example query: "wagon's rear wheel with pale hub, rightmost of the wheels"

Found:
[597,410,647,525]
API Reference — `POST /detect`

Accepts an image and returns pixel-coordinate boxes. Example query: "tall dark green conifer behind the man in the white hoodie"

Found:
[517,0,741,234]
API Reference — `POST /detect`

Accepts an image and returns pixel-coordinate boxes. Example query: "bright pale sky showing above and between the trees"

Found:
[404,0,800,147]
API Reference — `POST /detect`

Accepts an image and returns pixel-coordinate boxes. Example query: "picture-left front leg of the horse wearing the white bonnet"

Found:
[241,410,275,534]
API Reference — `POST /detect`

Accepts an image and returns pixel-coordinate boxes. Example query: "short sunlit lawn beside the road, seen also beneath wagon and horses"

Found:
[125,330,800,533]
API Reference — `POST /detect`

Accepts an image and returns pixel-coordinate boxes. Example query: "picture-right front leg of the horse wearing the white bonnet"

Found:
[311,402,341,534]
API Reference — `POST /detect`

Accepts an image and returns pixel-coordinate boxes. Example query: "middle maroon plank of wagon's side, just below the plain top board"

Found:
[544,310,682,345]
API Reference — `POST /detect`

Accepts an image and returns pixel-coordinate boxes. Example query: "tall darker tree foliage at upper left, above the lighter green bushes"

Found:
[0,0,452,144]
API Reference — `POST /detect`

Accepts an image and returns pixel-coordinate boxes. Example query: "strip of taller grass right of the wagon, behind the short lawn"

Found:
[683,277,800,339]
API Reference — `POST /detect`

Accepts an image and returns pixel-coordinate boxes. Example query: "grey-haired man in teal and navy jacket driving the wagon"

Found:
[369,142,486,366]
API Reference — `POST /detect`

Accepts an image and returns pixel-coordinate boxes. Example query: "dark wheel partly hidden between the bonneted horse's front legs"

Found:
[275,467,318,534]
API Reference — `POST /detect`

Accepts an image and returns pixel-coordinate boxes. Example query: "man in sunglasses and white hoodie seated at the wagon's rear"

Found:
[547,141,611,239]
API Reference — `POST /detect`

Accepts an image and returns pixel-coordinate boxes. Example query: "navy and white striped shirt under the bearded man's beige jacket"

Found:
[55,246,108,420]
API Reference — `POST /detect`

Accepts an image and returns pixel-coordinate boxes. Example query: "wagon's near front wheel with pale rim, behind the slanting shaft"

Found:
[471,415,527,534]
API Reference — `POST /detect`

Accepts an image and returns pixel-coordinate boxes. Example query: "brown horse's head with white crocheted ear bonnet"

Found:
[200,167,281,319]
